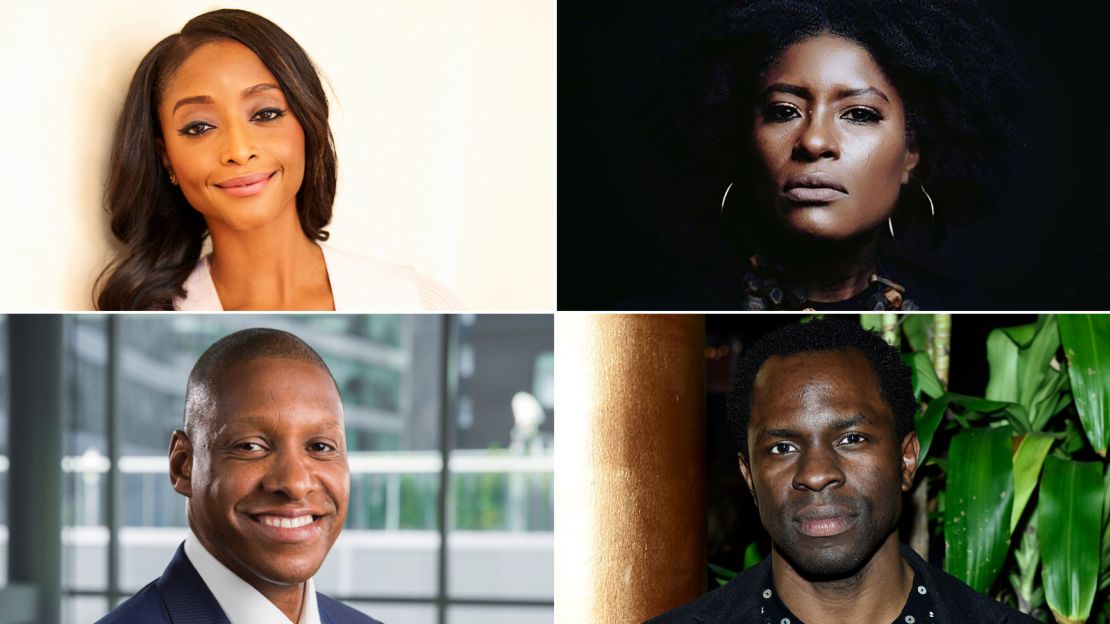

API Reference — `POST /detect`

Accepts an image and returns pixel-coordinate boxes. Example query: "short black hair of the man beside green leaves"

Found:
[728,318,917,459]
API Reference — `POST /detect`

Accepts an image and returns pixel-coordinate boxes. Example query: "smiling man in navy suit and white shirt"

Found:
[100,329,380,624]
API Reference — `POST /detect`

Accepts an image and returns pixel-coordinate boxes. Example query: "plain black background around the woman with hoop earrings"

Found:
[558,0,1110,311]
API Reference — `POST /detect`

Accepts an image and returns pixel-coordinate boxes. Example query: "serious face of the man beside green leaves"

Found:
[740,350,918,580]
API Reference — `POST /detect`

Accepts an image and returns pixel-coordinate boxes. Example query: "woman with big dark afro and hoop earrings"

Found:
[654,0,1027,311]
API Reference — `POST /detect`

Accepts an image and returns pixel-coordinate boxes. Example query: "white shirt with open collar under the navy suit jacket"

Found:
[185,530,320,624]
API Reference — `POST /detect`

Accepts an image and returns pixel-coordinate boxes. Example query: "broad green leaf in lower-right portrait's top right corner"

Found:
[1059,314,1110,450]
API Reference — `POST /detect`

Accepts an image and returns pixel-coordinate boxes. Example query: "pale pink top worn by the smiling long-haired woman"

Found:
[173,245,465,312]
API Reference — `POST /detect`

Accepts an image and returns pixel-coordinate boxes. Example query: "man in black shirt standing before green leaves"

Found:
[650,320,1036,624]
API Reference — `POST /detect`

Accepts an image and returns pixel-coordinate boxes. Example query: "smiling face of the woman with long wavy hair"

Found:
[158,40,304,231]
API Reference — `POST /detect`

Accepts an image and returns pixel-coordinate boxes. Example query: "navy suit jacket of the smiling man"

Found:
[97,544,382,624]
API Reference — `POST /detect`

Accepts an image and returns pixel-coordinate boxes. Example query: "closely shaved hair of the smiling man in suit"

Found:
[184,328,339,437]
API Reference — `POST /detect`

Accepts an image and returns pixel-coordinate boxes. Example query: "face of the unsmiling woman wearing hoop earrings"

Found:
[753,34,918,240]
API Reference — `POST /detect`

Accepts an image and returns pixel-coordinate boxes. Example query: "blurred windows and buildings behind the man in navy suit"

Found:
[0,314,555,624]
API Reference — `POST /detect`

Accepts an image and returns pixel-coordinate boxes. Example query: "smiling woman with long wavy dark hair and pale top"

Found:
[95,10,461,311]
